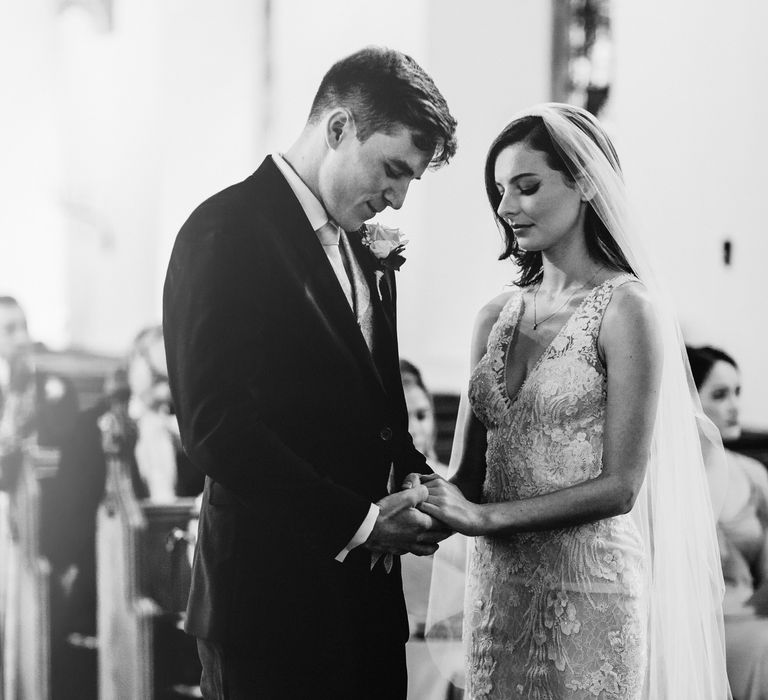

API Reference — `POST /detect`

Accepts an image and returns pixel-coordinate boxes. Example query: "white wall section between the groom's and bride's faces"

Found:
[398,0,552,391]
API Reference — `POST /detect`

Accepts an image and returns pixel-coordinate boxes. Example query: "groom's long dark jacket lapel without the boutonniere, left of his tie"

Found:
[256,158,386,395]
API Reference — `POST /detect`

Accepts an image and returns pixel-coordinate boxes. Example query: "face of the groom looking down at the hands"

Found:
[318,118,432,231]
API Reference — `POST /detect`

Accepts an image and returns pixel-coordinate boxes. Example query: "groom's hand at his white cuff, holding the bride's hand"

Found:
[364,484,451,556]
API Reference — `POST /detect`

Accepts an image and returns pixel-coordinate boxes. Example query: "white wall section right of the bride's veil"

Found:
[611,0,768,427]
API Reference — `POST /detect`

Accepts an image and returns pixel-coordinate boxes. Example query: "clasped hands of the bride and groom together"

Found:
[365,474,480,556]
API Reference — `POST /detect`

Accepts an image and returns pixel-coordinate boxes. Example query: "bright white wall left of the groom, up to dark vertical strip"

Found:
[0,0,264,353]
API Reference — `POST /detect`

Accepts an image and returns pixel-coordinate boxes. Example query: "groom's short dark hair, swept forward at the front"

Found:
[308,47,456,167]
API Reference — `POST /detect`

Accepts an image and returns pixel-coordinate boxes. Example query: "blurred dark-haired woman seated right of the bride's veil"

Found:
[686,347,768,700]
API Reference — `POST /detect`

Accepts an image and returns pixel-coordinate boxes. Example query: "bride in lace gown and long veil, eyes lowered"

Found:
[421,104,730,700]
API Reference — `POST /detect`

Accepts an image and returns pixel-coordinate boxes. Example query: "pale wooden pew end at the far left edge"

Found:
[0,445,58,700]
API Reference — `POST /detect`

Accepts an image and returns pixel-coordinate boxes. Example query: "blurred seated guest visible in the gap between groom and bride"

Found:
[400,359,464,700]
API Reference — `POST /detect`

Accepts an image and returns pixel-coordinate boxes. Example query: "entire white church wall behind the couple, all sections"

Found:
[0,0,768,425]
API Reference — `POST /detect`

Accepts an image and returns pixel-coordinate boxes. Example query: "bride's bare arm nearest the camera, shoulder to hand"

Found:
[421,283,662,535]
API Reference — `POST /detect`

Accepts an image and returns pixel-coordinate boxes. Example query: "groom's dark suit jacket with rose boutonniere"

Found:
[164,158,430,663]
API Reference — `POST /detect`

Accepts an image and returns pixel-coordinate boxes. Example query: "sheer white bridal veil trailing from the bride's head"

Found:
[427,103,731,700]
